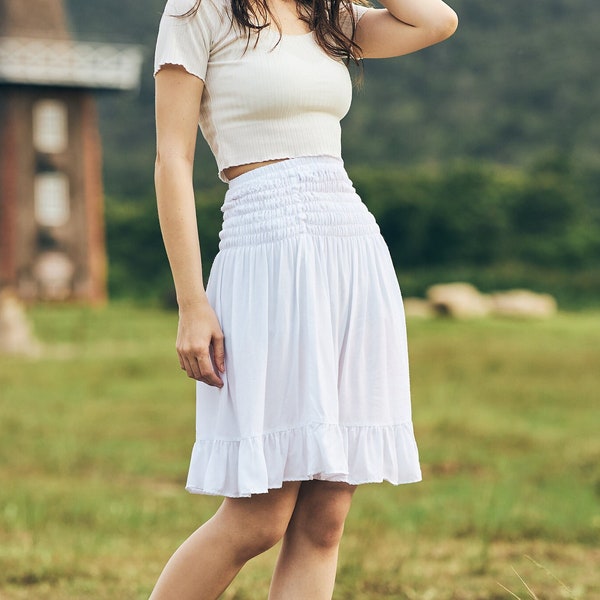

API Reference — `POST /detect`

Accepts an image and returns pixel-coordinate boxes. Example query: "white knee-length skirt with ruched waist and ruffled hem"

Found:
[186,156,421,497]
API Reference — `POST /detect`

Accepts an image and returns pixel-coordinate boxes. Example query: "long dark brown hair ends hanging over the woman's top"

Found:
[181,0,369,63]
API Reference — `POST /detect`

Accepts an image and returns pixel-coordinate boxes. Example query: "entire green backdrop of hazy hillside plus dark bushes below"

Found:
[66,0,600,306]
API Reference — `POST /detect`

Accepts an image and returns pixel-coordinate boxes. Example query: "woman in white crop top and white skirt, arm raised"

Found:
[151,0,457,600]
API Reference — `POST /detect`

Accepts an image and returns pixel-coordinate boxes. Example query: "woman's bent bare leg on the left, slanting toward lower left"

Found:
[150,482,300,600]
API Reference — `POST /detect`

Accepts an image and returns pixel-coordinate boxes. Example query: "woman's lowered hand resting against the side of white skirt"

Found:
[176,301,225,388]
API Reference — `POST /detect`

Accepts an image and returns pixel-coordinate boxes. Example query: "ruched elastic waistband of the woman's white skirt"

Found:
[219,156,379,250]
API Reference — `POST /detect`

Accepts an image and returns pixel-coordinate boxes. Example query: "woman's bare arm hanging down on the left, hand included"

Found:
[155,65,225,387]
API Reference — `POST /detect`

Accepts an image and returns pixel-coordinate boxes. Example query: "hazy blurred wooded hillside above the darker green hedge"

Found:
[67,0,600,197]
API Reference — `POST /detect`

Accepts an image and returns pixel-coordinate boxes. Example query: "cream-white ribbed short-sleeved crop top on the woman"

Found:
[154,0,369,181]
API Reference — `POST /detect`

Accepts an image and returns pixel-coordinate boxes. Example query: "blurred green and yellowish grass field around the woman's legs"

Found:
[0,305,600,600]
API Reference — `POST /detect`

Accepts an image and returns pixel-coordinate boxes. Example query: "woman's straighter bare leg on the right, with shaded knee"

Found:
[269,481,356,600]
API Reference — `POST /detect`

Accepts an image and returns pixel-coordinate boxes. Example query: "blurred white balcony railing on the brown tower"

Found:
[0,37,143,90]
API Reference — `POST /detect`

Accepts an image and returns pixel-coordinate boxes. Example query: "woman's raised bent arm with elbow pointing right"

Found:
[355,0,458,58]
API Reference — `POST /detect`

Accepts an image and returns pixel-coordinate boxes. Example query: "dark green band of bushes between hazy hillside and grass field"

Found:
[107,155,600,306]
